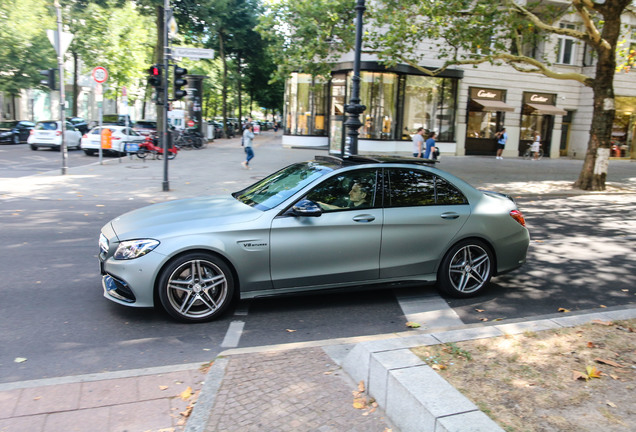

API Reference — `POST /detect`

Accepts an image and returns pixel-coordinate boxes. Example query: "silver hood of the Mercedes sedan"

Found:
[110,195,263,240]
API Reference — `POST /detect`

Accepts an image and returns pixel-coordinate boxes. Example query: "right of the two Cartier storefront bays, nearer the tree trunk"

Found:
[518,92,567,156]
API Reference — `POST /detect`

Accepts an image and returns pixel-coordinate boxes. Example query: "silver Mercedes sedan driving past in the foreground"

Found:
[99,156,529,322]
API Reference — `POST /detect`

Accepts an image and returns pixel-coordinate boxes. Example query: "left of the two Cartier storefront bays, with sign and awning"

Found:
[465,87,515,156]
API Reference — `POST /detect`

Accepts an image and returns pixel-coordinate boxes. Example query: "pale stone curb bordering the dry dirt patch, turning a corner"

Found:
[342,308,636,432]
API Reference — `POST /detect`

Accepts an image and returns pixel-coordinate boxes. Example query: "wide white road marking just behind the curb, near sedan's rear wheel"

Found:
[395,288,464,329]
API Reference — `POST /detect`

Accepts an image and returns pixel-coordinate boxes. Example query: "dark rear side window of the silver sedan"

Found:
[387,169,468,207]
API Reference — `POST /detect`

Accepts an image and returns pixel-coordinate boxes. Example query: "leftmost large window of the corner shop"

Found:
[285,73,328,136]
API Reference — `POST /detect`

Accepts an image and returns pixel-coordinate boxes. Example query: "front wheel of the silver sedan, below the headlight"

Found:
[157,252,234,323]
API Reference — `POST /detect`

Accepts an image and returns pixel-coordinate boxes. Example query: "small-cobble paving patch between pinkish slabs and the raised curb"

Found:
[206,348,391,432]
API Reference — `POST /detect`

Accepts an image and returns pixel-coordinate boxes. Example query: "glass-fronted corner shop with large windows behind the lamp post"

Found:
[283,62,463,153]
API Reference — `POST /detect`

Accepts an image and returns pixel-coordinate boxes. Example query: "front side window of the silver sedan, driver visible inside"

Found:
[305,169,377,212]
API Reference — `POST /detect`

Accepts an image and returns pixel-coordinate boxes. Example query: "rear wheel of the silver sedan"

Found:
[437,239,495,298]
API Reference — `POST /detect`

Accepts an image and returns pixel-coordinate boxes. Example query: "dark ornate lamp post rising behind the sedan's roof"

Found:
[341,0,367,156]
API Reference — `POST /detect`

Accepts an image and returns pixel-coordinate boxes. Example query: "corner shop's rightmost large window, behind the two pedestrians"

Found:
[401,75,457,141]
